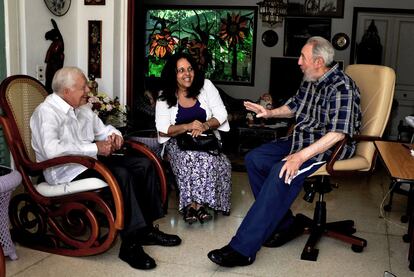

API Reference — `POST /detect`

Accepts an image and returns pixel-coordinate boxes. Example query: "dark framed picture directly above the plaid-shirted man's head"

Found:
[283,17,331,57]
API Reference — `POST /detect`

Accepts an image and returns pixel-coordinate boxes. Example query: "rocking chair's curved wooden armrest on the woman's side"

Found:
[125,140,167,204]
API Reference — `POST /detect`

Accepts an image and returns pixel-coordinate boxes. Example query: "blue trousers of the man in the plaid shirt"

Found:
[230,139,321,259]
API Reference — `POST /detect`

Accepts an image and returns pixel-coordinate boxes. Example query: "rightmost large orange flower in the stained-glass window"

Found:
[219,13,249,47]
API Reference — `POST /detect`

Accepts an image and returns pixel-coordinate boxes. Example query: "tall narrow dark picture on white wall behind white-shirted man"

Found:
[88,20,102,78]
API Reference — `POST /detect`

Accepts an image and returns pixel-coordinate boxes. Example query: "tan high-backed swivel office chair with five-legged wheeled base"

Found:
[297,64,395,261]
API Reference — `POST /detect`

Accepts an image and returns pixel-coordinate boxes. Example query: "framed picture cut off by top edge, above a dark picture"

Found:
[288,0,345,18]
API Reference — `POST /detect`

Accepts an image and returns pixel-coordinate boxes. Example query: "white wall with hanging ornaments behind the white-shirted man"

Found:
[19,0,126,100]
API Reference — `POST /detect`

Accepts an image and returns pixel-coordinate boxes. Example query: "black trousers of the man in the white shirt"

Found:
[75,155,164,238]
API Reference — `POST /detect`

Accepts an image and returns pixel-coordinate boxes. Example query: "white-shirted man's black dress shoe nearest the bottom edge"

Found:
[119,241,157,269]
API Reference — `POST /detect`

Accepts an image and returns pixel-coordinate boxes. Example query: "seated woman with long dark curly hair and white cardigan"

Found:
[155,53,231,224]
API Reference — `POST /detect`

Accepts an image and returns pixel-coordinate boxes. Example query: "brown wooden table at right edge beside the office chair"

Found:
[374,141,414,271]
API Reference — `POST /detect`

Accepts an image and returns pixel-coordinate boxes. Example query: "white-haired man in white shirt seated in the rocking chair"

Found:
[30,67,181,269]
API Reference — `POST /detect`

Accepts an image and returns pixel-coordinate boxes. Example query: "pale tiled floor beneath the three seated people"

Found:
[6,165,414,277]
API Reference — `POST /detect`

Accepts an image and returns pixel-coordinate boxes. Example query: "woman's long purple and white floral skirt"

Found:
[166,138,231,212]
